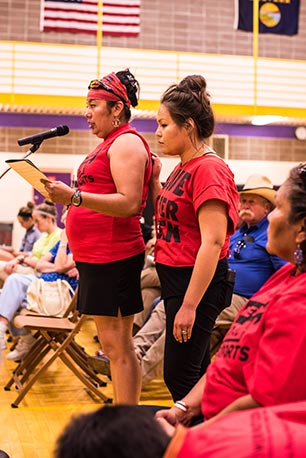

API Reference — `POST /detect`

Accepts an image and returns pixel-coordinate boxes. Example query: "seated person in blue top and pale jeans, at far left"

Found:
[0,230,78,361]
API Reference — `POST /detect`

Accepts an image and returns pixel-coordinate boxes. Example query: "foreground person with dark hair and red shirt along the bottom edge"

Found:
[54,401,306,458]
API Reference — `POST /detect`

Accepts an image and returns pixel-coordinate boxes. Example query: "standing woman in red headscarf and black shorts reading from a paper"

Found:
[45,70,152,404]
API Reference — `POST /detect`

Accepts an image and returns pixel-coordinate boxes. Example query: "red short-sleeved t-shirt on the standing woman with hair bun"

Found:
[154,154,239,267]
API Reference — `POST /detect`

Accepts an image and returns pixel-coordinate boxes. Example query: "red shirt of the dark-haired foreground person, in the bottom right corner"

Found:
[164,401,306,458]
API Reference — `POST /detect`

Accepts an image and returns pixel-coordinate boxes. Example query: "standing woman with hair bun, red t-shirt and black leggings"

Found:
[152,75,239,401]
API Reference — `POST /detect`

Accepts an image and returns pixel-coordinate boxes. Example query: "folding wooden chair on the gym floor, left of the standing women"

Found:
[4,293,112,408]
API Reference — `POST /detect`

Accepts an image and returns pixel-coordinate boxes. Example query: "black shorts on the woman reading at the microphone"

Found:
[76,253,144,316]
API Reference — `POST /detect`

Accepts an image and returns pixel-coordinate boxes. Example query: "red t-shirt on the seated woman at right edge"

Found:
[202,263,306,418]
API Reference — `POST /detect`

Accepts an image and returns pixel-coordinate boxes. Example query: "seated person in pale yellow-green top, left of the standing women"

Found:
[0,200,61,282]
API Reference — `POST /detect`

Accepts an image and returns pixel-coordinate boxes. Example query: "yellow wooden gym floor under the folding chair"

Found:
[0,319,172,458]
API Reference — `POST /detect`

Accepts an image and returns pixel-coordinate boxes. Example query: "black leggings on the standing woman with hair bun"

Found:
[164,259,228,401]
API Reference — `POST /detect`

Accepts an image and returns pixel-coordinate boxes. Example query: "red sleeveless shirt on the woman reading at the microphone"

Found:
[66,124,152,264]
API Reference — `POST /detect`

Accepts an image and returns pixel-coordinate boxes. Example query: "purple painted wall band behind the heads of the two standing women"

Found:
[0,113,295,138]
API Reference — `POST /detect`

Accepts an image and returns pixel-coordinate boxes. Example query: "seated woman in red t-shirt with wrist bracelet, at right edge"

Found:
[156,164,306,426]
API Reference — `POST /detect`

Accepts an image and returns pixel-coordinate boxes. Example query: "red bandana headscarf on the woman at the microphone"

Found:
[87,72,131,108]
